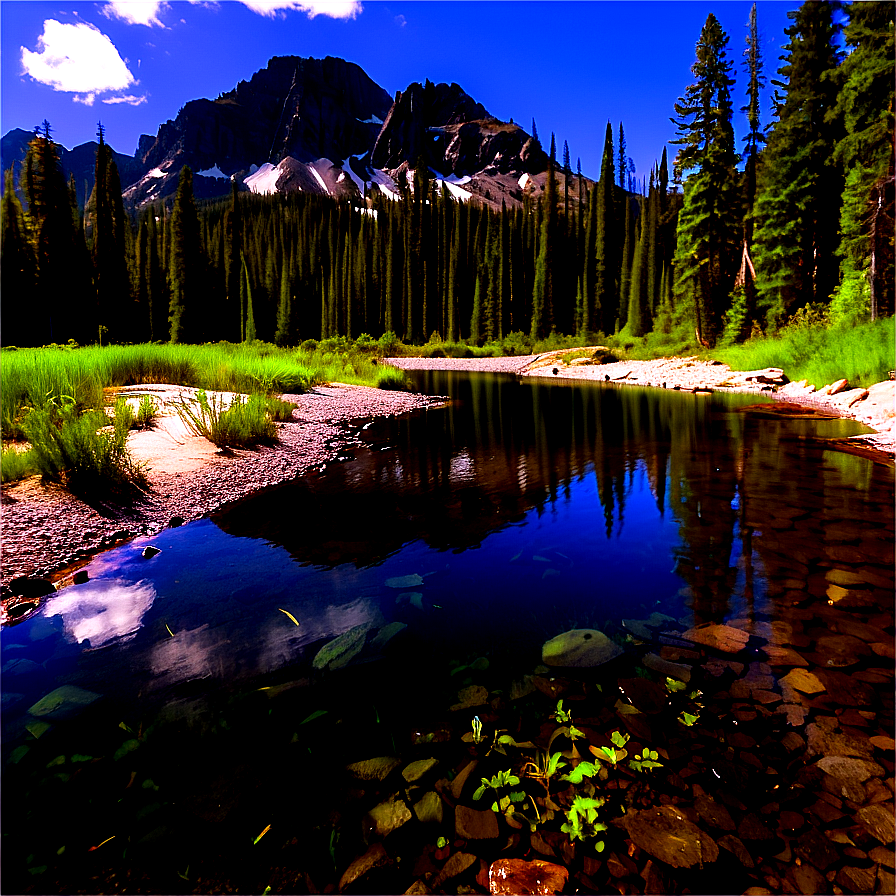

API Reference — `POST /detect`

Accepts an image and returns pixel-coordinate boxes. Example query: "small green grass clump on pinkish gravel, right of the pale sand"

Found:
[175,389,277,448]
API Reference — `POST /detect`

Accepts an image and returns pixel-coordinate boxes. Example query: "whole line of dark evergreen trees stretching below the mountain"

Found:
[2,0,894,346]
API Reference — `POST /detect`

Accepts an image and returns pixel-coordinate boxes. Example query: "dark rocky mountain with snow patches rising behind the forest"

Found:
[2,56,588,208]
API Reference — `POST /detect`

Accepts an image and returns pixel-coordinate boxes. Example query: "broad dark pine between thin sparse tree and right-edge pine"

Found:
[753,2,843,327]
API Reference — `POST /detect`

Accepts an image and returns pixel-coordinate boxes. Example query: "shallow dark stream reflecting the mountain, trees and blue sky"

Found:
[0,372,894,892]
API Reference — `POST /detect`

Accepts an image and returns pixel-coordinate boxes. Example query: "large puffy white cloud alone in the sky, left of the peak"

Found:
[21,19,135,99]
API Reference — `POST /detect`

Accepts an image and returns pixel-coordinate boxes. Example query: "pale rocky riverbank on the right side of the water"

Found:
[385,346,896,459]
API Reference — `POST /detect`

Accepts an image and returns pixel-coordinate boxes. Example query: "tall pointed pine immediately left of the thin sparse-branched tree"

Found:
[672,13,740,346]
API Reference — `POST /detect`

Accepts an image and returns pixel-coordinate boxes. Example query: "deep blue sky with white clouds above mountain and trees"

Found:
[0,0,798,178]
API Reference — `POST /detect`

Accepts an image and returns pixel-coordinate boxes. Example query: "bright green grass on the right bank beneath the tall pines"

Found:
[712,317,896,388]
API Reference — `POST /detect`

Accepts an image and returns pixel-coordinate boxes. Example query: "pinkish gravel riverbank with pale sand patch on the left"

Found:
[0,384,442,586]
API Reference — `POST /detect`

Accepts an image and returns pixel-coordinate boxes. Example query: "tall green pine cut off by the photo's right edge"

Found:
[831,3,894,320]
